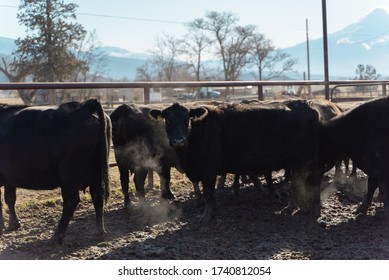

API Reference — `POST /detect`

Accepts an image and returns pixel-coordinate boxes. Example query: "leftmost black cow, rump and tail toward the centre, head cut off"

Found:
[0,100,111,243]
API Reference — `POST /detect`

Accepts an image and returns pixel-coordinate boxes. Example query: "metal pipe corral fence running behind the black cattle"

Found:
[0,80,389,109]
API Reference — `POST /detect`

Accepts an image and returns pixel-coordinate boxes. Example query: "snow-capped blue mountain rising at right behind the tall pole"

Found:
[283,8,389,79]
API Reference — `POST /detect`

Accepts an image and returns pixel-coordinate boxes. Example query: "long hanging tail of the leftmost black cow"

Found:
[91,99,112,203]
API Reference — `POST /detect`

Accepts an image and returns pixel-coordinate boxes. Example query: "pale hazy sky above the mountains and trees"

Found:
[0,0,389,52]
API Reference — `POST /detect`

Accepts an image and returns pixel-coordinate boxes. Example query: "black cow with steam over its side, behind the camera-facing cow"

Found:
[110,104,200,211]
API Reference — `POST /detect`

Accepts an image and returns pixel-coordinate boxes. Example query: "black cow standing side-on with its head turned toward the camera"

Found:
[150,101,320,222]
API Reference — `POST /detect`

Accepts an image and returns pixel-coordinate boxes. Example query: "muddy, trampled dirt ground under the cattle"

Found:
[0,145,389,260]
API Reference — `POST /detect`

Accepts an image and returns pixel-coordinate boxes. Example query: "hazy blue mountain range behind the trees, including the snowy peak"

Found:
[0,8,389,81]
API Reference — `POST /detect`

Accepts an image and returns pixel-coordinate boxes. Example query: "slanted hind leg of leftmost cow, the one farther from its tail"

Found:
[51,189,80,243]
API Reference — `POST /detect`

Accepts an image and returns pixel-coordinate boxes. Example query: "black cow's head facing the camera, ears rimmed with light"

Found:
[149,103,208,148]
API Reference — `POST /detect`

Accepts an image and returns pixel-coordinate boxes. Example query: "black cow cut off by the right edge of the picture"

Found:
[320,98,389,217]
